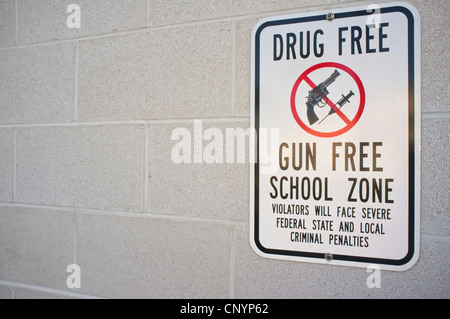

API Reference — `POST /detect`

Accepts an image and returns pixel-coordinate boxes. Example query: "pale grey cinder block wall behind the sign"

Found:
[0,0,450,298]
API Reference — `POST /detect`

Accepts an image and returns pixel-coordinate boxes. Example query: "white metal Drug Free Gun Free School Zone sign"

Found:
[250,3,421,270]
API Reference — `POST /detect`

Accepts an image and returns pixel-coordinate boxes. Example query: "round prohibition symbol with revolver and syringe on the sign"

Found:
[291,62,365,137]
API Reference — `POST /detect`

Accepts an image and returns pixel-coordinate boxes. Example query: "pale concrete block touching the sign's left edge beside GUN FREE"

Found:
[148,122,250,220]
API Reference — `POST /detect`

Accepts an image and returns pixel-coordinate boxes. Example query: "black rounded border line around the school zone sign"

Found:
[252,6,416,266]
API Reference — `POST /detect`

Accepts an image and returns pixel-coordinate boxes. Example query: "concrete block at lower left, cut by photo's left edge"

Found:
[0,207,74,289]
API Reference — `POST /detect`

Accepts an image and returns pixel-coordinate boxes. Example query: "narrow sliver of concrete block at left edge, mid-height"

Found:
[0,128,14,202]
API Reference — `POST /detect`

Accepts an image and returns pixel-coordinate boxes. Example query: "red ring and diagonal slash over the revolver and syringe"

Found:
[291,62,366,137]
